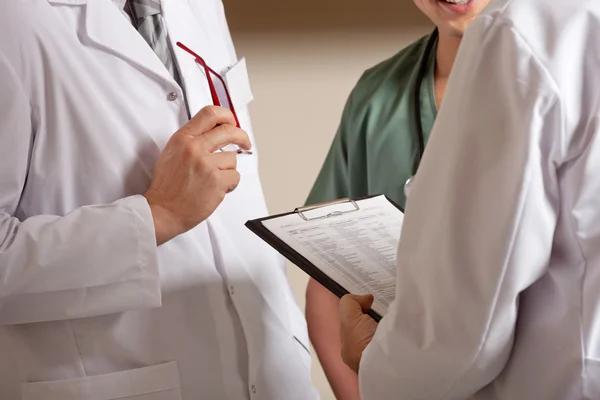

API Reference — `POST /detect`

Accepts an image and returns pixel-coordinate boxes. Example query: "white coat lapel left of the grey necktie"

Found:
[49,0,177,86]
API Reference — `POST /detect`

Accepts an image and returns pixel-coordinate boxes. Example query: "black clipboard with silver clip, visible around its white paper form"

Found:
[245,195,404,322]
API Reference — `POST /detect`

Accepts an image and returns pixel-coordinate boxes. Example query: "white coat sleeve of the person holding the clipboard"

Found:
[359,17,564,400]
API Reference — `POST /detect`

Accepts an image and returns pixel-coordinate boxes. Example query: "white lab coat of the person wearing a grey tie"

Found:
[0,0,318,400]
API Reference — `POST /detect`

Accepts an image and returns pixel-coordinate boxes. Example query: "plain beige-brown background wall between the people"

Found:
[224,0,431,400]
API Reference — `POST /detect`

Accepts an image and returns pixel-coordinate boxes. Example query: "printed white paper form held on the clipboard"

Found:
[262,196,404,316]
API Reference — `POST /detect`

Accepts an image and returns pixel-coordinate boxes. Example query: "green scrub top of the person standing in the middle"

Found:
[307,36,437,207]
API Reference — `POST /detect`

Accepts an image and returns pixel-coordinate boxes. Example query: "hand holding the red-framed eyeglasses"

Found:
[144,106,252,245]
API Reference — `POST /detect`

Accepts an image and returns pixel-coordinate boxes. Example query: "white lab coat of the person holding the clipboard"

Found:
[359,0,600,400]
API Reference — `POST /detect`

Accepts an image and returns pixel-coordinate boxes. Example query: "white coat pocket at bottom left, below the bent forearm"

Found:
[21,362,182,400]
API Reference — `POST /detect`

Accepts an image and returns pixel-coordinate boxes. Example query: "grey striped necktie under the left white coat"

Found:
[125,0,181,86]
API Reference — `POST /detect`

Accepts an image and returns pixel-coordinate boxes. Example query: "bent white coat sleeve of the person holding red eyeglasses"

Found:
[0,52,161,325]
